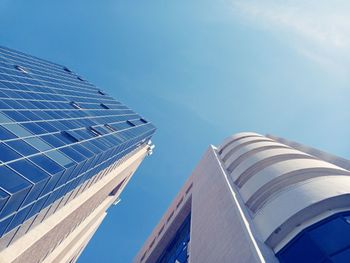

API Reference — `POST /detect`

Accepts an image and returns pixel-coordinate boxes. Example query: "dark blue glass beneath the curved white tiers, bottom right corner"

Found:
[276,212,350,263]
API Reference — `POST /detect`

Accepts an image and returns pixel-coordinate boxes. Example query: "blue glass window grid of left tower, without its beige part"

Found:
[0,47,155,237]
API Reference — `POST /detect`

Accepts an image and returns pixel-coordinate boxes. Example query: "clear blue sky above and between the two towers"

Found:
[0,0,350,263]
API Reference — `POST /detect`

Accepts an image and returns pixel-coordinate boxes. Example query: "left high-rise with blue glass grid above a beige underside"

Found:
[0,47,155,263]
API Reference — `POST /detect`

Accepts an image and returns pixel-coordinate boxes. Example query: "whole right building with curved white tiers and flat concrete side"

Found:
[134,133,350,263]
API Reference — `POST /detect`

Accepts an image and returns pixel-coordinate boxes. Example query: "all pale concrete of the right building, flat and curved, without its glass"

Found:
[134,132,350,263]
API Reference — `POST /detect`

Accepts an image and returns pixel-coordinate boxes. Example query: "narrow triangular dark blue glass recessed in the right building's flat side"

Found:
[157,215,191,263]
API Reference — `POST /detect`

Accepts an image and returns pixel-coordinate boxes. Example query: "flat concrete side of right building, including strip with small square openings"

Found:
[133,147,276,263]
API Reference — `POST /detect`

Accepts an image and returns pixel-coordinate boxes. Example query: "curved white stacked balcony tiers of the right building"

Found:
[219,133,350,252]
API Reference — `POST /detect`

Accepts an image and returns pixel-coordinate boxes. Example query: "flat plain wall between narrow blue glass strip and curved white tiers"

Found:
[190,147,268,263]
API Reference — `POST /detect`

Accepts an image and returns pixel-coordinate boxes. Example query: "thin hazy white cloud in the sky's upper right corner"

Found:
[231,0,350,71]
